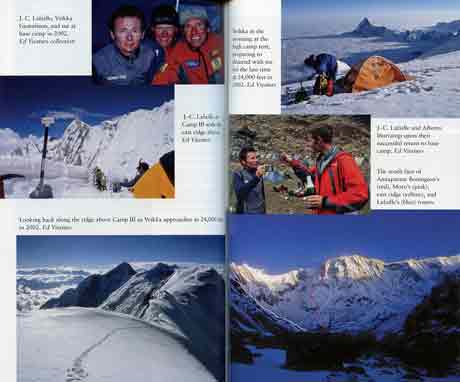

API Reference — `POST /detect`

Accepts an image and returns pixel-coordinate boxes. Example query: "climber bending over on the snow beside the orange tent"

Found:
[304,53,337,97]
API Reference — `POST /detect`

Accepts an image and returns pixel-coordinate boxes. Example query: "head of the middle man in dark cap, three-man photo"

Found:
[150,4,179,58]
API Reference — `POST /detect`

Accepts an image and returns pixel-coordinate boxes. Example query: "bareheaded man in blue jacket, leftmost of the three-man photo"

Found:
[93,5,163,85]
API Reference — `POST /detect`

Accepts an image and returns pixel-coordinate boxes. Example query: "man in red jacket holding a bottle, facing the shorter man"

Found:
[281,126,369,215]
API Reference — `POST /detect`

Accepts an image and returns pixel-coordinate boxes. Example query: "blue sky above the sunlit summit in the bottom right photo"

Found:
[228,211,460,273]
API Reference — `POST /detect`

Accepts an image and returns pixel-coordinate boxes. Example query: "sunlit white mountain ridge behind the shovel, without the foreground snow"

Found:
[0,101,174,178]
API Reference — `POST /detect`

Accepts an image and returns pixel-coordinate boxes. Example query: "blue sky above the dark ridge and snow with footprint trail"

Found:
[17,236,224,268]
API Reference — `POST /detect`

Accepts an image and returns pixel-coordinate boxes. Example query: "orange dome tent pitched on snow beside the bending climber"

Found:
[344,56,409,93]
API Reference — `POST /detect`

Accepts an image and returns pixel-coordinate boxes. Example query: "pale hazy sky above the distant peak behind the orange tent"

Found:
[283,0,460,37]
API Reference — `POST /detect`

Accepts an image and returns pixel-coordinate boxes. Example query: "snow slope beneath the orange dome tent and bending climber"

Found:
[282,50,460,118]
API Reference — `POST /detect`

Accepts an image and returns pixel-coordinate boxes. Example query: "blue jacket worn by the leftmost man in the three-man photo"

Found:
[93,41,165,85]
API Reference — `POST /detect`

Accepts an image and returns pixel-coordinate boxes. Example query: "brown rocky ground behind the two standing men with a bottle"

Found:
[230,115,370,214]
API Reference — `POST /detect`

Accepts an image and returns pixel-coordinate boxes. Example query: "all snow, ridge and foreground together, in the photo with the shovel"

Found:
[0,101,174,198]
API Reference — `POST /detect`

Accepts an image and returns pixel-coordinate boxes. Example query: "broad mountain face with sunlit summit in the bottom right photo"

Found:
[231,255,460,335]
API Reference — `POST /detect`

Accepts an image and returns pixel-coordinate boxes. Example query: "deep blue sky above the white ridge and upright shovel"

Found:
[0,77,174,137]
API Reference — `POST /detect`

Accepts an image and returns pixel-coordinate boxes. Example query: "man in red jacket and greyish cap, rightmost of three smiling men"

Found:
[152,6,224,85]
